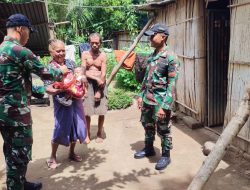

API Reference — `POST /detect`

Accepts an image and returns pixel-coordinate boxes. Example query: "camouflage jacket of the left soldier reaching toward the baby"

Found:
[0,36,62,127]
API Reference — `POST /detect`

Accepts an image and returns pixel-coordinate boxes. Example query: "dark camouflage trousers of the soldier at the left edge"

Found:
[0,126,33,190]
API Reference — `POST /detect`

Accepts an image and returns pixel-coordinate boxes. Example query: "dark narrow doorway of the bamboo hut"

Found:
[206,0,230,132]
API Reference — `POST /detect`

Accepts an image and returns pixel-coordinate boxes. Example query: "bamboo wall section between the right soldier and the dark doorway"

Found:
[156,0,207,123]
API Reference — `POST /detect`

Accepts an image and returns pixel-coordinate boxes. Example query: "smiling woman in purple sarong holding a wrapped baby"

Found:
[46,39,87,169]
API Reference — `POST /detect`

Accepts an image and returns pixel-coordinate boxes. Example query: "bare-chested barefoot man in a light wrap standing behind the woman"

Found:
[82,33,108,143]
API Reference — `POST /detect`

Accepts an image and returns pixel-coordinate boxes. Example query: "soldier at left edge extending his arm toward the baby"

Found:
[0,14,67,190]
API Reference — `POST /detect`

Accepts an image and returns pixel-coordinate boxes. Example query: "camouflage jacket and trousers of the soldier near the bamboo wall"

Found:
[139,46,180,156]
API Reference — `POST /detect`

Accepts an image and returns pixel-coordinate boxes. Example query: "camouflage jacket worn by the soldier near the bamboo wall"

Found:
[139,46,180,110]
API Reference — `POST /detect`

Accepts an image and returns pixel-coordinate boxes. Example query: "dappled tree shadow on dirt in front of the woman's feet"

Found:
[24,148,161,190]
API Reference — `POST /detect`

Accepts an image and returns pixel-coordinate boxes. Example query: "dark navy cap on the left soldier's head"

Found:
[6,13,37,33]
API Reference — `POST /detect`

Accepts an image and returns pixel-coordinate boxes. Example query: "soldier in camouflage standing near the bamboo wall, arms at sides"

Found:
[134,23,180,170]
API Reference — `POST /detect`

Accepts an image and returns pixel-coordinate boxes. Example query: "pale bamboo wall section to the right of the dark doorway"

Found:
[224,0,250,153]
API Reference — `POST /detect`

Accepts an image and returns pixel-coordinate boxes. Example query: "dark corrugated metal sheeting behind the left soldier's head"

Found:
[0,2,49,55]
